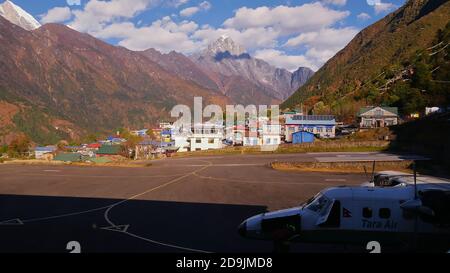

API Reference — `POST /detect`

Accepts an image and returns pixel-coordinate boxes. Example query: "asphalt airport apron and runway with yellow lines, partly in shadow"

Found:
[0,153,392,253]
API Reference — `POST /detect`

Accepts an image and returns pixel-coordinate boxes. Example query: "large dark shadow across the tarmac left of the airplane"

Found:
[0,195,272,253]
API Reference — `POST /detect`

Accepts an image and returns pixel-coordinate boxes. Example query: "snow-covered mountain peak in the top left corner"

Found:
[0,1,41,30]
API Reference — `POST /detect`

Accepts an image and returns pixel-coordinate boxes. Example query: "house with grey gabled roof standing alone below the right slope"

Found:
[358,106,399,129]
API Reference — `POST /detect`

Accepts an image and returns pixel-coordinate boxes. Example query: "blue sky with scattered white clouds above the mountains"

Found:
[13,0,405,70]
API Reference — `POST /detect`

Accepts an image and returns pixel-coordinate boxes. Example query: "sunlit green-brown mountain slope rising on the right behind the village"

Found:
[281,0,450,119]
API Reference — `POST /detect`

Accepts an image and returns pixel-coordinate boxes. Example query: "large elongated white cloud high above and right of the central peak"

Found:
[224,2,350,35]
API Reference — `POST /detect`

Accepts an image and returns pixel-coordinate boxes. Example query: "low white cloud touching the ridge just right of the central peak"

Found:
[255,49,317,71]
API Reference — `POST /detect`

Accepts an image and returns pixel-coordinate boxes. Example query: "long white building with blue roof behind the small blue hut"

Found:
[285,114,336,142]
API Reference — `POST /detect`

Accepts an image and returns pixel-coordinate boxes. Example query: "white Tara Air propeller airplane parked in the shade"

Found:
[238,165,450,252]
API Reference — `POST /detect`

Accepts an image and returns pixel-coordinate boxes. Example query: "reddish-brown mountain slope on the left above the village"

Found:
[0,17,230,143]
